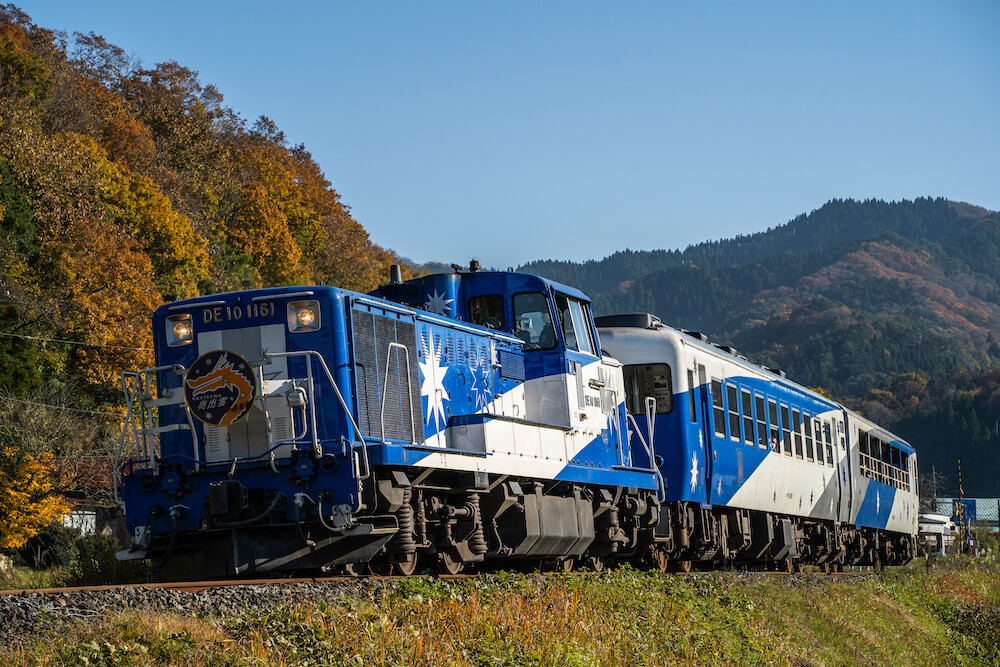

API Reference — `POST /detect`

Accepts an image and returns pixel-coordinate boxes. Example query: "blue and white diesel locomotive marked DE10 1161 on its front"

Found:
[116,266,660,576]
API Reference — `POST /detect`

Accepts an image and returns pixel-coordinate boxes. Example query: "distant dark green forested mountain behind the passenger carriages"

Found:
[522,199,1000,495]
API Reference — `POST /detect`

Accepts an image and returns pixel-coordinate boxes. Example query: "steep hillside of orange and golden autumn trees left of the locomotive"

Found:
[0,5,406,462]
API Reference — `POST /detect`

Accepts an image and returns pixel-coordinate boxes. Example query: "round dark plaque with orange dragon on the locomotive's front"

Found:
[184,350,257,426]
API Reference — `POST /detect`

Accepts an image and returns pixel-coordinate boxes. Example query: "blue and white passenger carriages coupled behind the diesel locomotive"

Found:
[597,314,918,569]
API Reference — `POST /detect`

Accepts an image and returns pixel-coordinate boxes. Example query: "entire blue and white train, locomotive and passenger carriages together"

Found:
[115,261,917,578]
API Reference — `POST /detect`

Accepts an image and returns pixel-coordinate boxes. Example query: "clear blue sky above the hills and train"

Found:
[9,0,1000,267]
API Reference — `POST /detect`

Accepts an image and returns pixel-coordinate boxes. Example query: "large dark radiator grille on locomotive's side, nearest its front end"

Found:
[351,310,423,442]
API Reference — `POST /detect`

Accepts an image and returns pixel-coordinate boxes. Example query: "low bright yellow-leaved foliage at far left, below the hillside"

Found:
[0,445,69,549]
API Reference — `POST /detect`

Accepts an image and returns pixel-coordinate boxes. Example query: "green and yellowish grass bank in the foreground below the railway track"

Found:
[0,560,1000,666]
